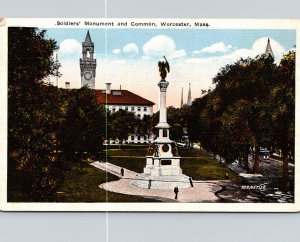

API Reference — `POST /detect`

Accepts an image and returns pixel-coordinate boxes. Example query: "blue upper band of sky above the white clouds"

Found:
[47,29,295,58]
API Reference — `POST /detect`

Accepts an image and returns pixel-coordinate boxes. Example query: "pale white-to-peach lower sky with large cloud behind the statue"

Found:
[53,35,286,109]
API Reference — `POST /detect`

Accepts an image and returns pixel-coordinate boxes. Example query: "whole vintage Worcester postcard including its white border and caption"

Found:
[0,18,300,212]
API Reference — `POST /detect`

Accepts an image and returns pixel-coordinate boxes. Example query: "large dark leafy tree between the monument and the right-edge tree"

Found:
[190,56,277,173]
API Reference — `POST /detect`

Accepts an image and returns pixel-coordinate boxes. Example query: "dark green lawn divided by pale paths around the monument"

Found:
[57,146,237,202]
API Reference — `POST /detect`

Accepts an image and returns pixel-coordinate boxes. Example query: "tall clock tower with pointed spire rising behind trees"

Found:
[80,31,97,89]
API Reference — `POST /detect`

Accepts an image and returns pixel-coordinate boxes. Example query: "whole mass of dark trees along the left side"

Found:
[8,28,105,202]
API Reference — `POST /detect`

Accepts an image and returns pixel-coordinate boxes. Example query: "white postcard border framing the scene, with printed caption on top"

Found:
[0,18,300,212]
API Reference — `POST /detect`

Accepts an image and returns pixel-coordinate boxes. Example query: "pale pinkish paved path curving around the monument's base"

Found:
[91,161,224,202]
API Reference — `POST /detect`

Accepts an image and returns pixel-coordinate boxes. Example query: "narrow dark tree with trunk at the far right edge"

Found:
[269,51,295,190]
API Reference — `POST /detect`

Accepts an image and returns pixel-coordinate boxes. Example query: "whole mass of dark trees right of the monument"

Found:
[188,51,295,189]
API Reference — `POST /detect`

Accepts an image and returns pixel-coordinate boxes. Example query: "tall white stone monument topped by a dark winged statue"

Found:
[132,57,191,189]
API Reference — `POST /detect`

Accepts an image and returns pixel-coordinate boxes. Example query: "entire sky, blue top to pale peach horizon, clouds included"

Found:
[47,28,296,107]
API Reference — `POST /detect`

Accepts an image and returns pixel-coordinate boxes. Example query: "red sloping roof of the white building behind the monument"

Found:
[95,90,155,106]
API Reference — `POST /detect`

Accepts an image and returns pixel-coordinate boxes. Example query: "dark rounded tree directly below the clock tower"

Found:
[60,87,106,164]
